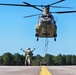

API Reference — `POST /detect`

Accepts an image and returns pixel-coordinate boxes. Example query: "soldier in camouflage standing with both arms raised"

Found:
[21,48,35,66]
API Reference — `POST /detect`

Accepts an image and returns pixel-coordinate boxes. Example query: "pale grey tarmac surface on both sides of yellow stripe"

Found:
[0,66,76,75]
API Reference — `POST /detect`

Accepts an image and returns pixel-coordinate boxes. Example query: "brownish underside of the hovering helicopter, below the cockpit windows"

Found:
[36,23,56,38]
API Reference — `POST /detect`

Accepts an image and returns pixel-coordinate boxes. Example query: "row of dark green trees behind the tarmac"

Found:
[0,52,76,66]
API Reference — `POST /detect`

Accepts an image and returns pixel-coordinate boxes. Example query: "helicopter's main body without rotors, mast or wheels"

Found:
[36,14,57,38]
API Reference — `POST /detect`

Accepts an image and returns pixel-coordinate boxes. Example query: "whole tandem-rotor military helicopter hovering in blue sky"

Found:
[0,0,76,41]
